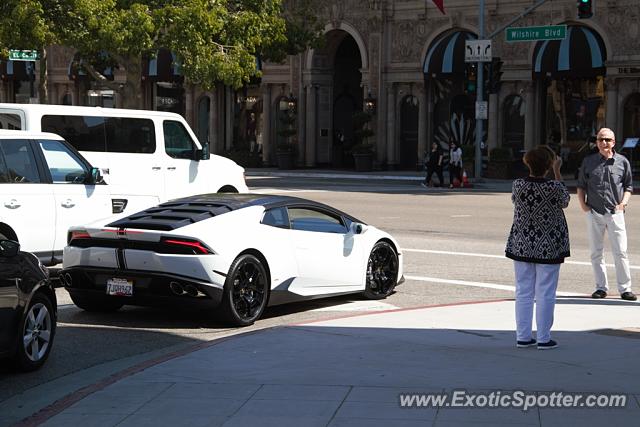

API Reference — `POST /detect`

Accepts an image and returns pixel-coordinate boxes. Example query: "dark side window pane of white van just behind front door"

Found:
[105,117,156,154]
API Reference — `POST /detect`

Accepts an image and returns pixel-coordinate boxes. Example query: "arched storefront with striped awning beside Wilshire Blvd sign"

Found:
[533,24,607,172]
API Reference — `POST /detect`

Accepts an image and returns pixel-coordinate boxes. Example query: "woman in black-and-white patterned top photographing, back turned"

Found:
[505,146,569,350]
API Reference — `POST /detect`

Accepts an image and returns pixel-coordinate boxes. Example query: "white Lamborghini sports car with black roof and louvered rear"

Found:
[61,194,403,325]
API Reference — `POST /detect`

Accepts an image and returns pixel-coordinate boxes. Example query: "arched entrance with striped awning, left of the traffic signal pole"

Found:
[423,29,477,157]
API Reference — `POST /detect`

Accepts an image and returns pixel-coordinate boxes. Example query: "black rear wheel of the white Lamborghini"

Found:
[222,254,269,326]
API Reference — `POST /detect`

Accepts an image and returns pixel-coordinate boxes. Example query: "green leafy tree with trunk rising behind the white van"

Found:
[0,0,320,108]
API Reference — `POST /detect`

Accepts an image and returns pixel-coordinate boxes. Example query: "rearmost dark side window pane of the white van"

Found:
[40,115,107,152]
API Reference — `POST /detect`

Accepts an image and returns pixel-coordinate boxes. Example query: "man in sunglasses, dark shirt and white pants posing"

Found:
[578,128,637,301]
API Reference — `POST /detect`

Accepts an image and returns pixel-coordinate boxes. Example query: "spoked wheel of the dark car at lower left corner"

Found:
[15,293,56,371]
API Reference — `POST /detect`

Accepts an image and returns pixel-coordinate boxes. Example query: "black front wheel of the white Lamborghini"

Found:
[364,241,399,299]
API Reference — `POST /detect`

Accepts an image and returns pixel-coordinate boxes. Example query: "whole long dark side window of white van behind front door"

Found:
[41,115,156,153]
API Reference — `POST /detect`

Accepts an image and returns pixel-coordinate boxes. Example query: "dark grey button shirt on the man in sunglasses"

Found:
[578,152,633,215]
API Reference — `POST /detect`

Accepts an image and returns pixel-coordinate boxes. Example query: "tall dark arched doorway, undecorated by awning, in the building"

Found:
[328,31,362,168]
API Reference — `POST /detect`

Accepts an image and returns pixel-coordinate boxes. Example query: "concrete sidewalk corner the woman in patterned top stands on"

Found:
[15,298,640,427]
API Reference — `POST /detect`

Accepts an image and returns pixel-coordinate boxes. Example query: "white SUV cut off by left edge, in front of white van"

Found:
[0,130,113,266]
